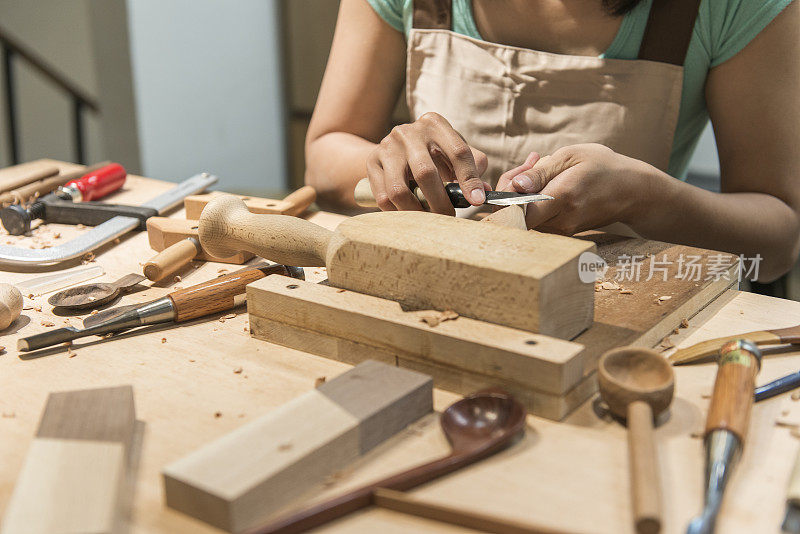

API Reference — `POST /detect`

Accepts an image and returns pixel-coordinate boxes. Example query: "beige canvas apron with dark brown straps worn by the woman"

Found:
[406,0,699,185]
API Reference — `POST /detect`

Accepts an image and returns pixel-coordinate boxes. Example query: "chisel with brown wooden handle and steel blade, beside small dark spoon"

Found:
[17,263,305,352]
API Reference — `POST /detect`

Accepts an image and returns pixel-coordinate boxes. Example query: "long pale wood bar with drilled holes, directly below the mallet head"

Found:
[247,276,584,394]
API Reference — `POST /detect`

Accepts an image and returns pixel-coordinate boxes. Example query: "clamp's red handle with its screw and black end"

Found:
[0,163,127,235]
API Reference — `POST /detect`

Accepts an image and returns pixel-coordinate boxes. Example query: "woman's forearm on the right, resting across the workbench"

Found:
[626,167,800,281]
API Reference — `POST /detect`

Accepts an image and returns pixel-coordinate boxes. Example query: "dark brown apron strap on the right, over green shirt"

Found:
[639,0,700,65]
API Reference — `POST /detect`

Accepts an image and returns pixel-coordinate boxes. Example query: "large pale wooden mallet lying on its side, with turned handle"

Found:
[198,195,595,339]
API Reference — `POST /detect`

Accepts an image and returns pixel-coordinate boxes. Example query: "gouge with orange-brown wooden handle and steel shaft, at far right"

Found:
[686,339,761,534]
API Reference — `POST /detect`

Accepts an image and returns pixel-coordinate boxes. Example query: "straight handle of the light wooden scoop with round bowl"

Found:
[628,401,661,533]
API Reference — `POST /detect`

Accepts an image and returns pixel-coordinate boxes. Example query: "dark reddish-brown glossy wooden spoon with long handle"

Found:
[250,389,525,534]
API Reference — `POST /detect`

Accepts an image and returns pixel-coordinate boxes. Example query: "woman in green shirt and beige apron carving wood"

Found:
[306,0,800,281]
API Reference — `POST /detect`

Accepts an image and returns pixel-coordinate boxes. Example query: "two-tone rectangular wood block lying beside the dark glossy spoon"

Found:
[163,361,433,532]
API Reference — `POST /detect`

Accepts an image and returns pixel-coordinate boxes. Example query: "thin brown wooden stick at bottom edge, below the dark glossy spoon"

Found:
[374,488,563,534]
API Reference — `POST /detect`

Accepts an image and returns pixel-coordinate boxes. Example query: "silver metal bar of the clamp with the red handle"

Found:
[0,173,217,266]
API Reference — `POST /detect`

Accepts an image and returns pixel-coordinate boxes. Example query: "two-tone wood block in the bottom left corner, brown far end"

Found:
[0,386,136,534]
